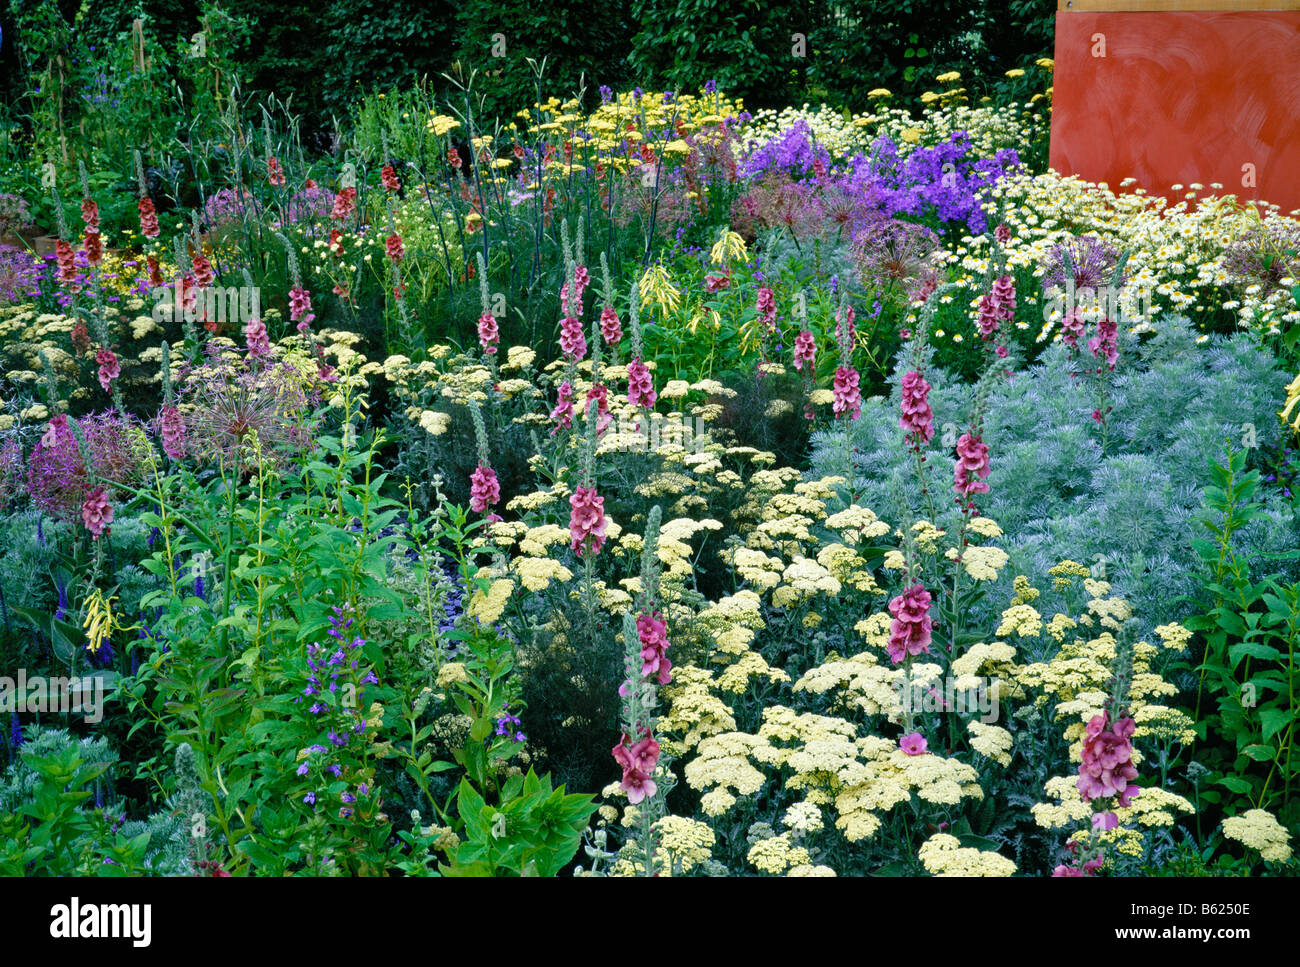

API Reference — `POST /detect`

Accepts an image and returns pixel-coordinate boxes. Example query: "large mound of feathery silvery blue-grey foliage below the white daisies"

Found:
[813,318,1300,624]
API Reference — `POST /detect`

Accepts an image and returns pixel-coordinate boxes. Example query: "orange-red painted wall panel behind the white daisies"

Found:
[1050,10,1300,212]
